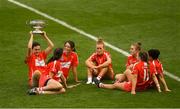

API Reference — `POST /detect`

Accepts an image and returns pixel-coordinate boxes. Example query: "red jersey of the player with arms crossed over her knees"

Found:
[90,51,112,67]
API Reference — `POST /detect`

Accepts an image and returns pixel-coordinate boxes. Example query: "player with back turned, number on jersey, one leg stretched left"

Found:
[94,52,161,94]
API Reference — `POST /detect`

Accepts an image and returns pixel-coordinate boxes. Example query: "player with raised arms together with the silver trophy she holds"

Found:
[25,20,54,87]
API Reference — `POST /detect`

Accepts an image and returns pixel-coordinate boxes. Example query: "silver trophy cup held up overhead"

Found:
[27,20,46,34]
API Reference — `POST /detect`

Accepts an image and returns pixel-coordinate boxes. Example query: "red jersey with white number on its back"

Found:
[132,61,155,90]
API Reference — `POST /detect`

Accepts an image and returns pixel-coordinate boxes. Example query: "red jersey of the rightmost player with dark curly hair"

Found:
[150,59,163,74]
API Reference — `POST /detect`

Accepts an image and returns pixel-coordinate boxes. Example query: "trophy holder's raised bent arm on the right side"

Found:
[42,31,54,55]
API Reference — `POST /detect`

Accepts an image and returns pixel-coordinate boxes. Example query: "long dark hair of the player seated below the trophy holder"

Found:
[47,48,63,64]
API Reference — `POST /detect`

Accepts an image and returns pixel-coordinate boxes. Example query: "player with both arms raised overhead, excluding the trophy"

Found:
[25,31,54,87]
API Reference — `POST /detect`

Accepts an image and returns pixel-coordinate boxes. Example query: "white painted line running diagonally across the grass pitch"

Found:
[8,0,180,82]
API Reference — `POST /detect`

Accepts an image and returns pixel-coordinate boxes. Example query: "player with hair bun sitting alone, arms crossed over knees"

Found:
[85,38,114,84]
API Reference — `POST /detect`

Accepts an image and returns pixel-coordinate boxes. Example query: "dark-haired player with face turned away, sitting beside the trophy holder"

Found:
[28,48,67,95]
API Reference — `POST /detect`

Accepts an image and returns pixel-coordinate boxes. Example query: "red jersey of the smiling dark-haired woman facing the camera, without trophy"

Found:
[60,52,79,78]
